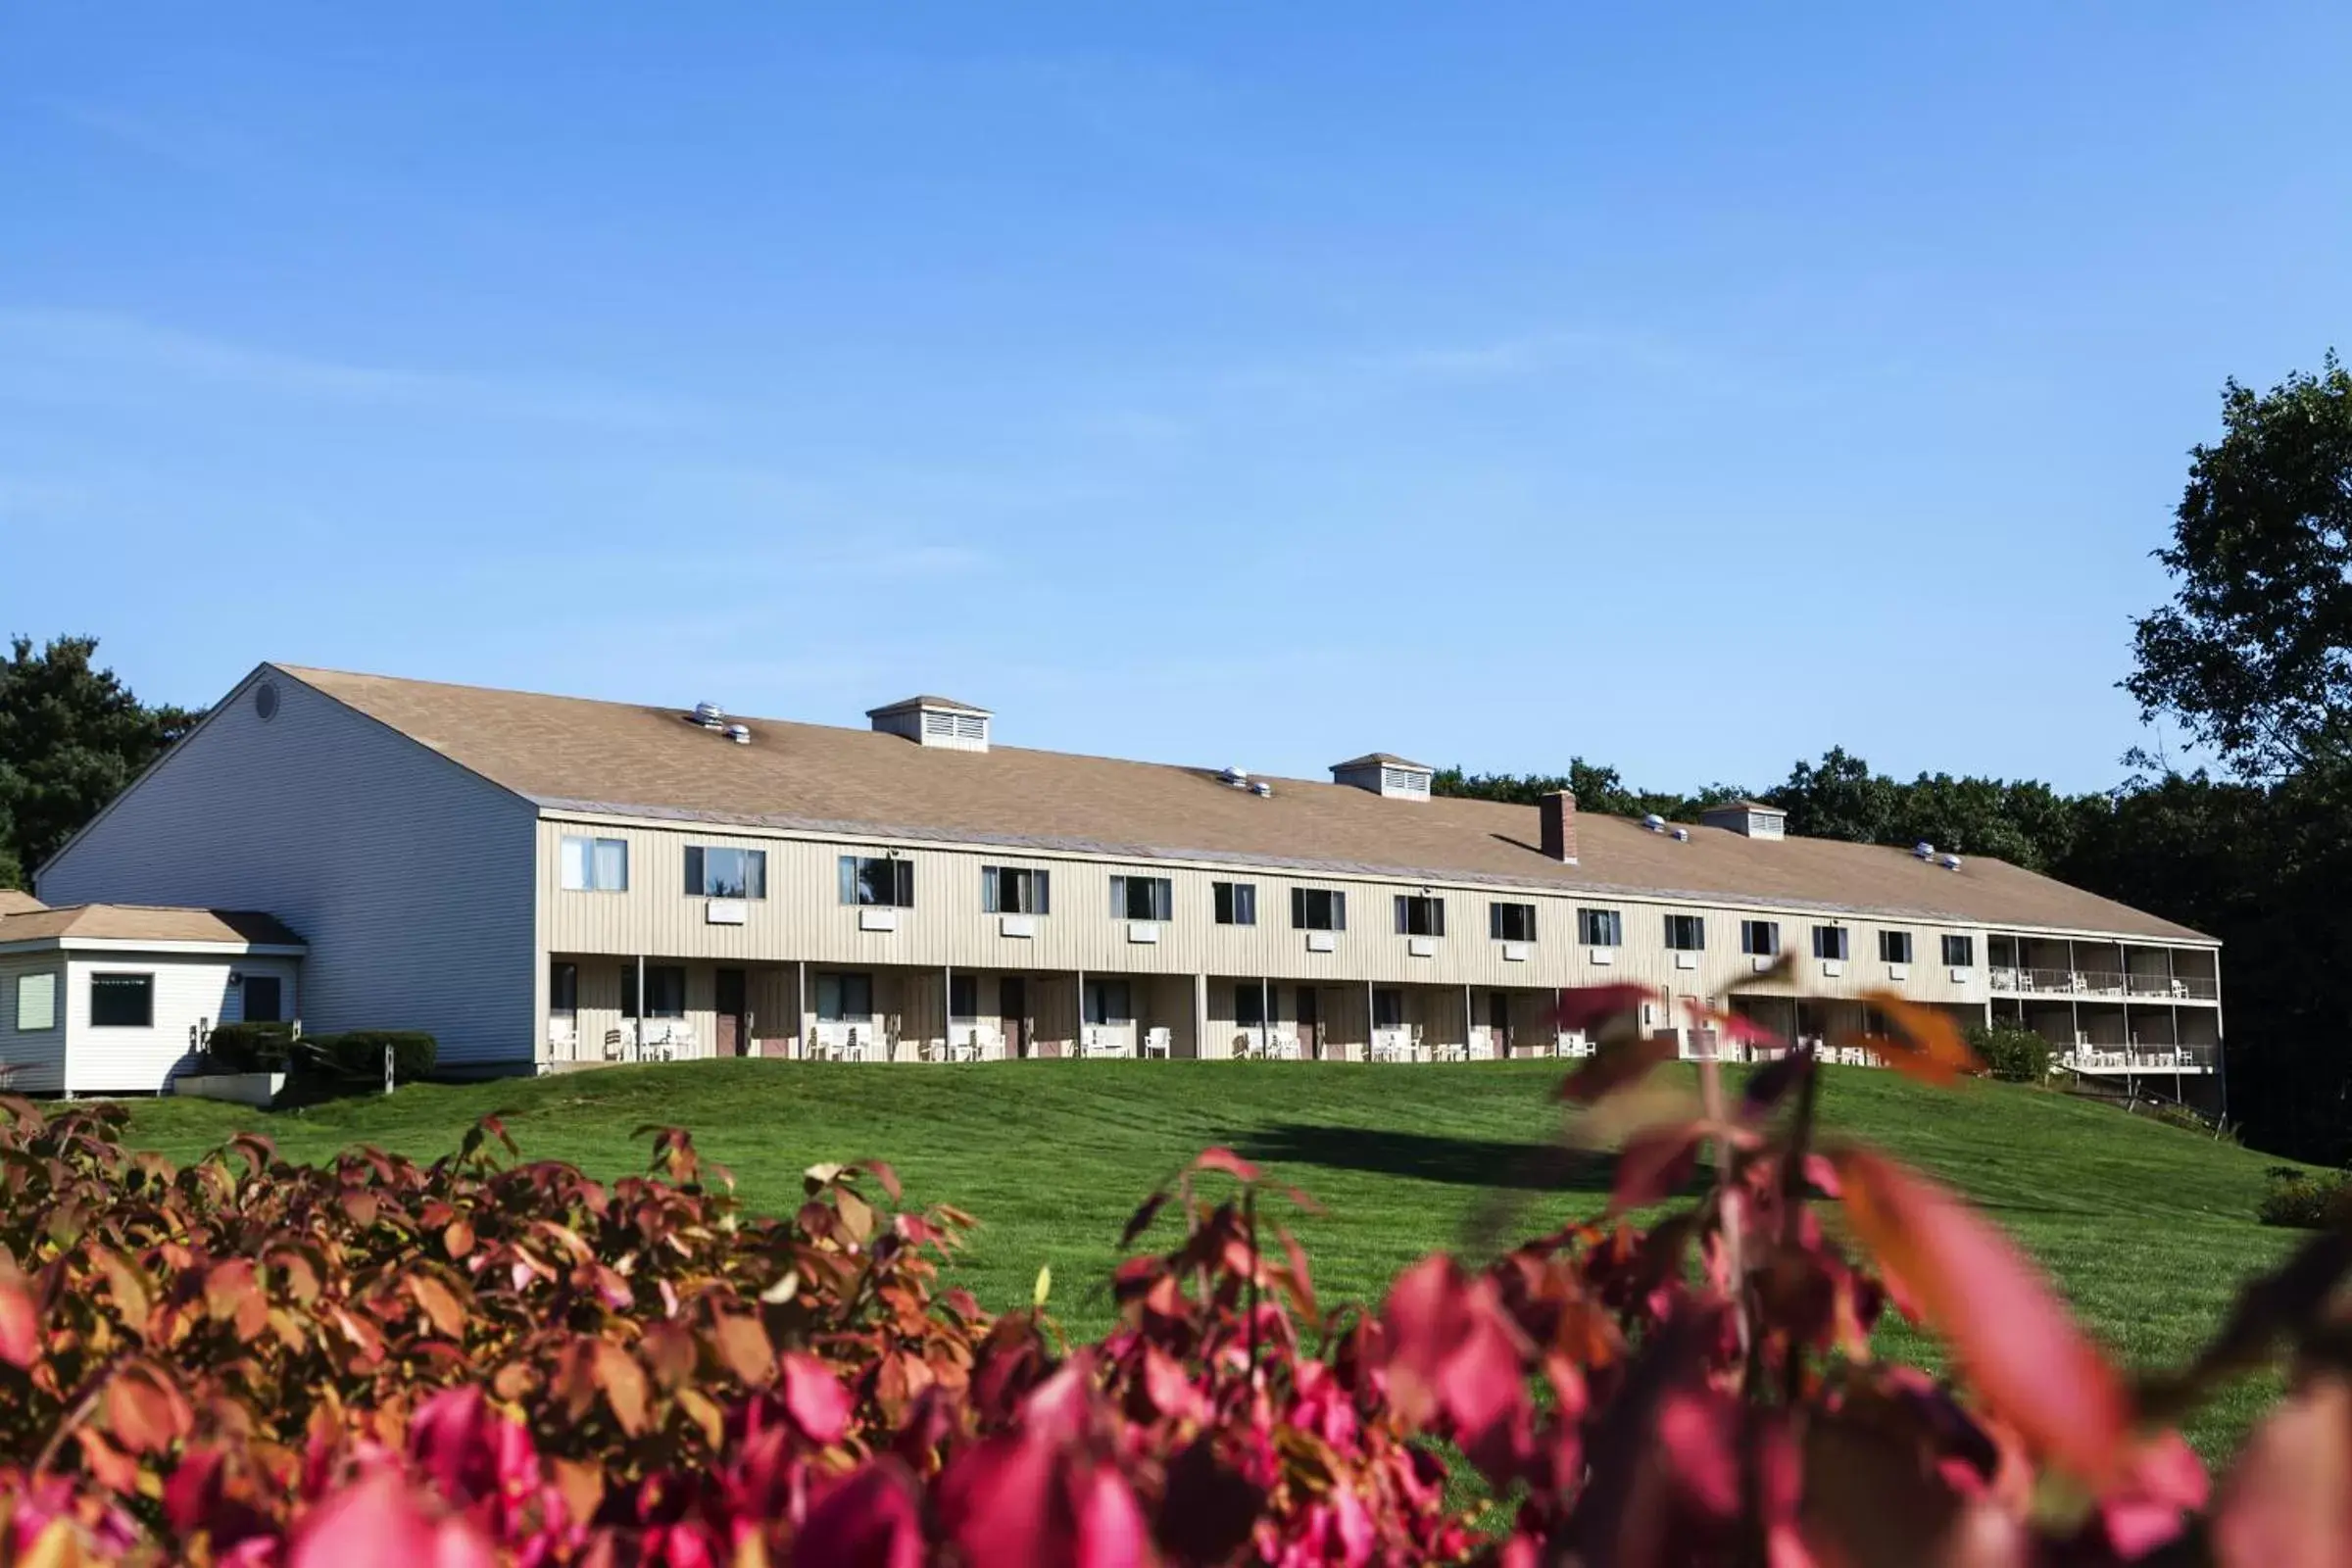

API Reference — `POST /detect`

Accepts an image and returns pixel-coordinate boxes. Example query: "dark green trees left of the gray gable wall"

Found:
[0,637,198,886]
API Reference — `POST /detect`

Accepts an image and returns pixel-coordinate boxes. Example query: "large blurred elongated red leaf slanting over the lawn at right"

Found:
[1833,1150,2131,1488]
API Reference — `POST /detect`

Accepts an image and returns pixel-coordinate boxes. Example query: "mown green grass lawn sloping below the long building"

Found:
[110,1060,2293,1457]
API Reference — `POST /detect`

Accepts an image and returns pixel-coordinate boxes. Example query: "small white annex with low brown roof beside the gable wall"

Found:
[0,894,308,1096]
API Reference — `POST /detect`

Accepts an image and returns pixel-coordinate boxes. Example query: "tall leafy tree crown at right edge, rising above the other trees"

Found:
[2124,353,2352,778]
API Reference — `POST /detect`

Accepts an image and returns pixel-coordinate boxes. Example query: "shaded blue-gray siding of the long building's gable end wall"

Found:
[40,672,539,1069]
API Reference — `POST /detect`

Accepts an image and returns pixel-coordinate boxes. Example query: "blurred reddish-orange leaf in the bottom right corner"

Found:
[2213,1378,2352,1568]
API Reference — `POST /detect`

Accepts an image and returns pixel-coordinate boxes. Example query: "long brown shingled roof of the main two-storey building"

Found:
[282,667,2204,941]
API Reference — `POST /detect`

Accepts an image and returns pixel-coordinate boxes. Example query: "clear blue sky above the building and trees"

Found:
[0,0,2352,788]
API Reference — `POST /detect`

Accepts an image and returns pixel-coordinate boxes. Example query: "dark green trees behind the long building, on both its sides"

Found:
[0,355,2352,1163]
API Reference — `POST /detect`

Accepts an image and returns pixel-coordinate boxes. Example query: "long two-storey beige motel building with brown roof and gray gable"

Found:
[14,662,2223,1093]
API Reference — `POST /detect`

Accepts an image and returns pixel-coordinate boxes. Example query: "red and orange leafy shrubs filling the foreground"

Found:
[0,987,2352,1568]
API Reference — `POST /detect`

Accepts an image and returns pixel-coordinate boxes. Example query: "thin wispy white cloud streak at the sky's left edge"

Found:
[0,308,687,428]
